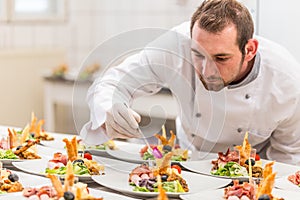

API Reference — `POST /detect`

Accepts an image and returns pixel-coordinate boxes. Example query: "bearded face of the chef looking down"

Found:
[191,24,247,91]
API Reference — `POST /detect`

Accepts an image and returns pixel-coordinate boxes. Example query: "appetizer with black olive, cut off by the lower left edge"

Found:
[0,168,23,194]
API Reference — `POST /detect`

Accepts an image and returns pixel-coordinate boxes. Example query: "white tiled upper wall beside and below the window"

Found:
[0,0,202,72]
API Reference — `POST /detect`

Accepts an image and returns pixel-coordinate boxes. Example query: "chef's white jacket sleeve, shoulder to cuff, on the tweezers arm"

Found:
[80,25,190,143]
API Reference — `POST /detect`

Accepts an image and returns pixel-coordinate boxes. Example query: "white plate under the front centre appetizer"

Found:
[92,170,231,198]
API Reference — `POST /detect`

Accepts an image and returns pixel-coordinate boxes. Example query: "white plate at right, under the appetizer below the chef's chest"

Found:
[180,159,297,181]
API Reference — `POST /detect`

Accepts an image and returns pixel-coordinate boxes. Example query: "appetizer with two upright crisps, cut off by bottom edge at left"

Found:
[23,161,103,200]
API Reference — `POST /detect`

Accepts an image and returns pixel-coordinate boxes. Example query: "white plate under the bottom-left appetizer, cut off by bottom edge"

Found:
[1,188,138,200]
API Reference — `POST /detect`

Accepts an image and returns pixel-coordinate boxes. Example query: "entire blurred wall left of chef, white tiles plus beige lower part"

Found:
[0,0,202,132]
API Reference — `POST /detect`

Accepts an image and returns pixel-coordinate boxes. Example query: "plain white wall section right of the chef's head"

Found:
[258,0,300,62]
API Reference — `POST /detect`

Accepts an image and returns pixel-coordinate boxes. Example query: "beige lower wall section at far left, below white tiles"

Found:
[0,49,65,127]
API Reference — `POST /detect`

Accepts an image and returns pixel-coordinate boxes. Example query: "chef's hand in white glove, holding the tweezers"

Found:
[105,103,141,138]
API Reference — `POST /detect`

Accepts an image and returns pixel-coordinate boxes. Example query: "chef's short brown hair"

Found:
[190,0,254,54]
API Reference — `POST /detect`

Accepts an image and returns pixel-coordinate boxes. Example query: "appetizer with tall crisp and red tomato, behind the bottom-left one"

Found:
[45,136,104,175]
